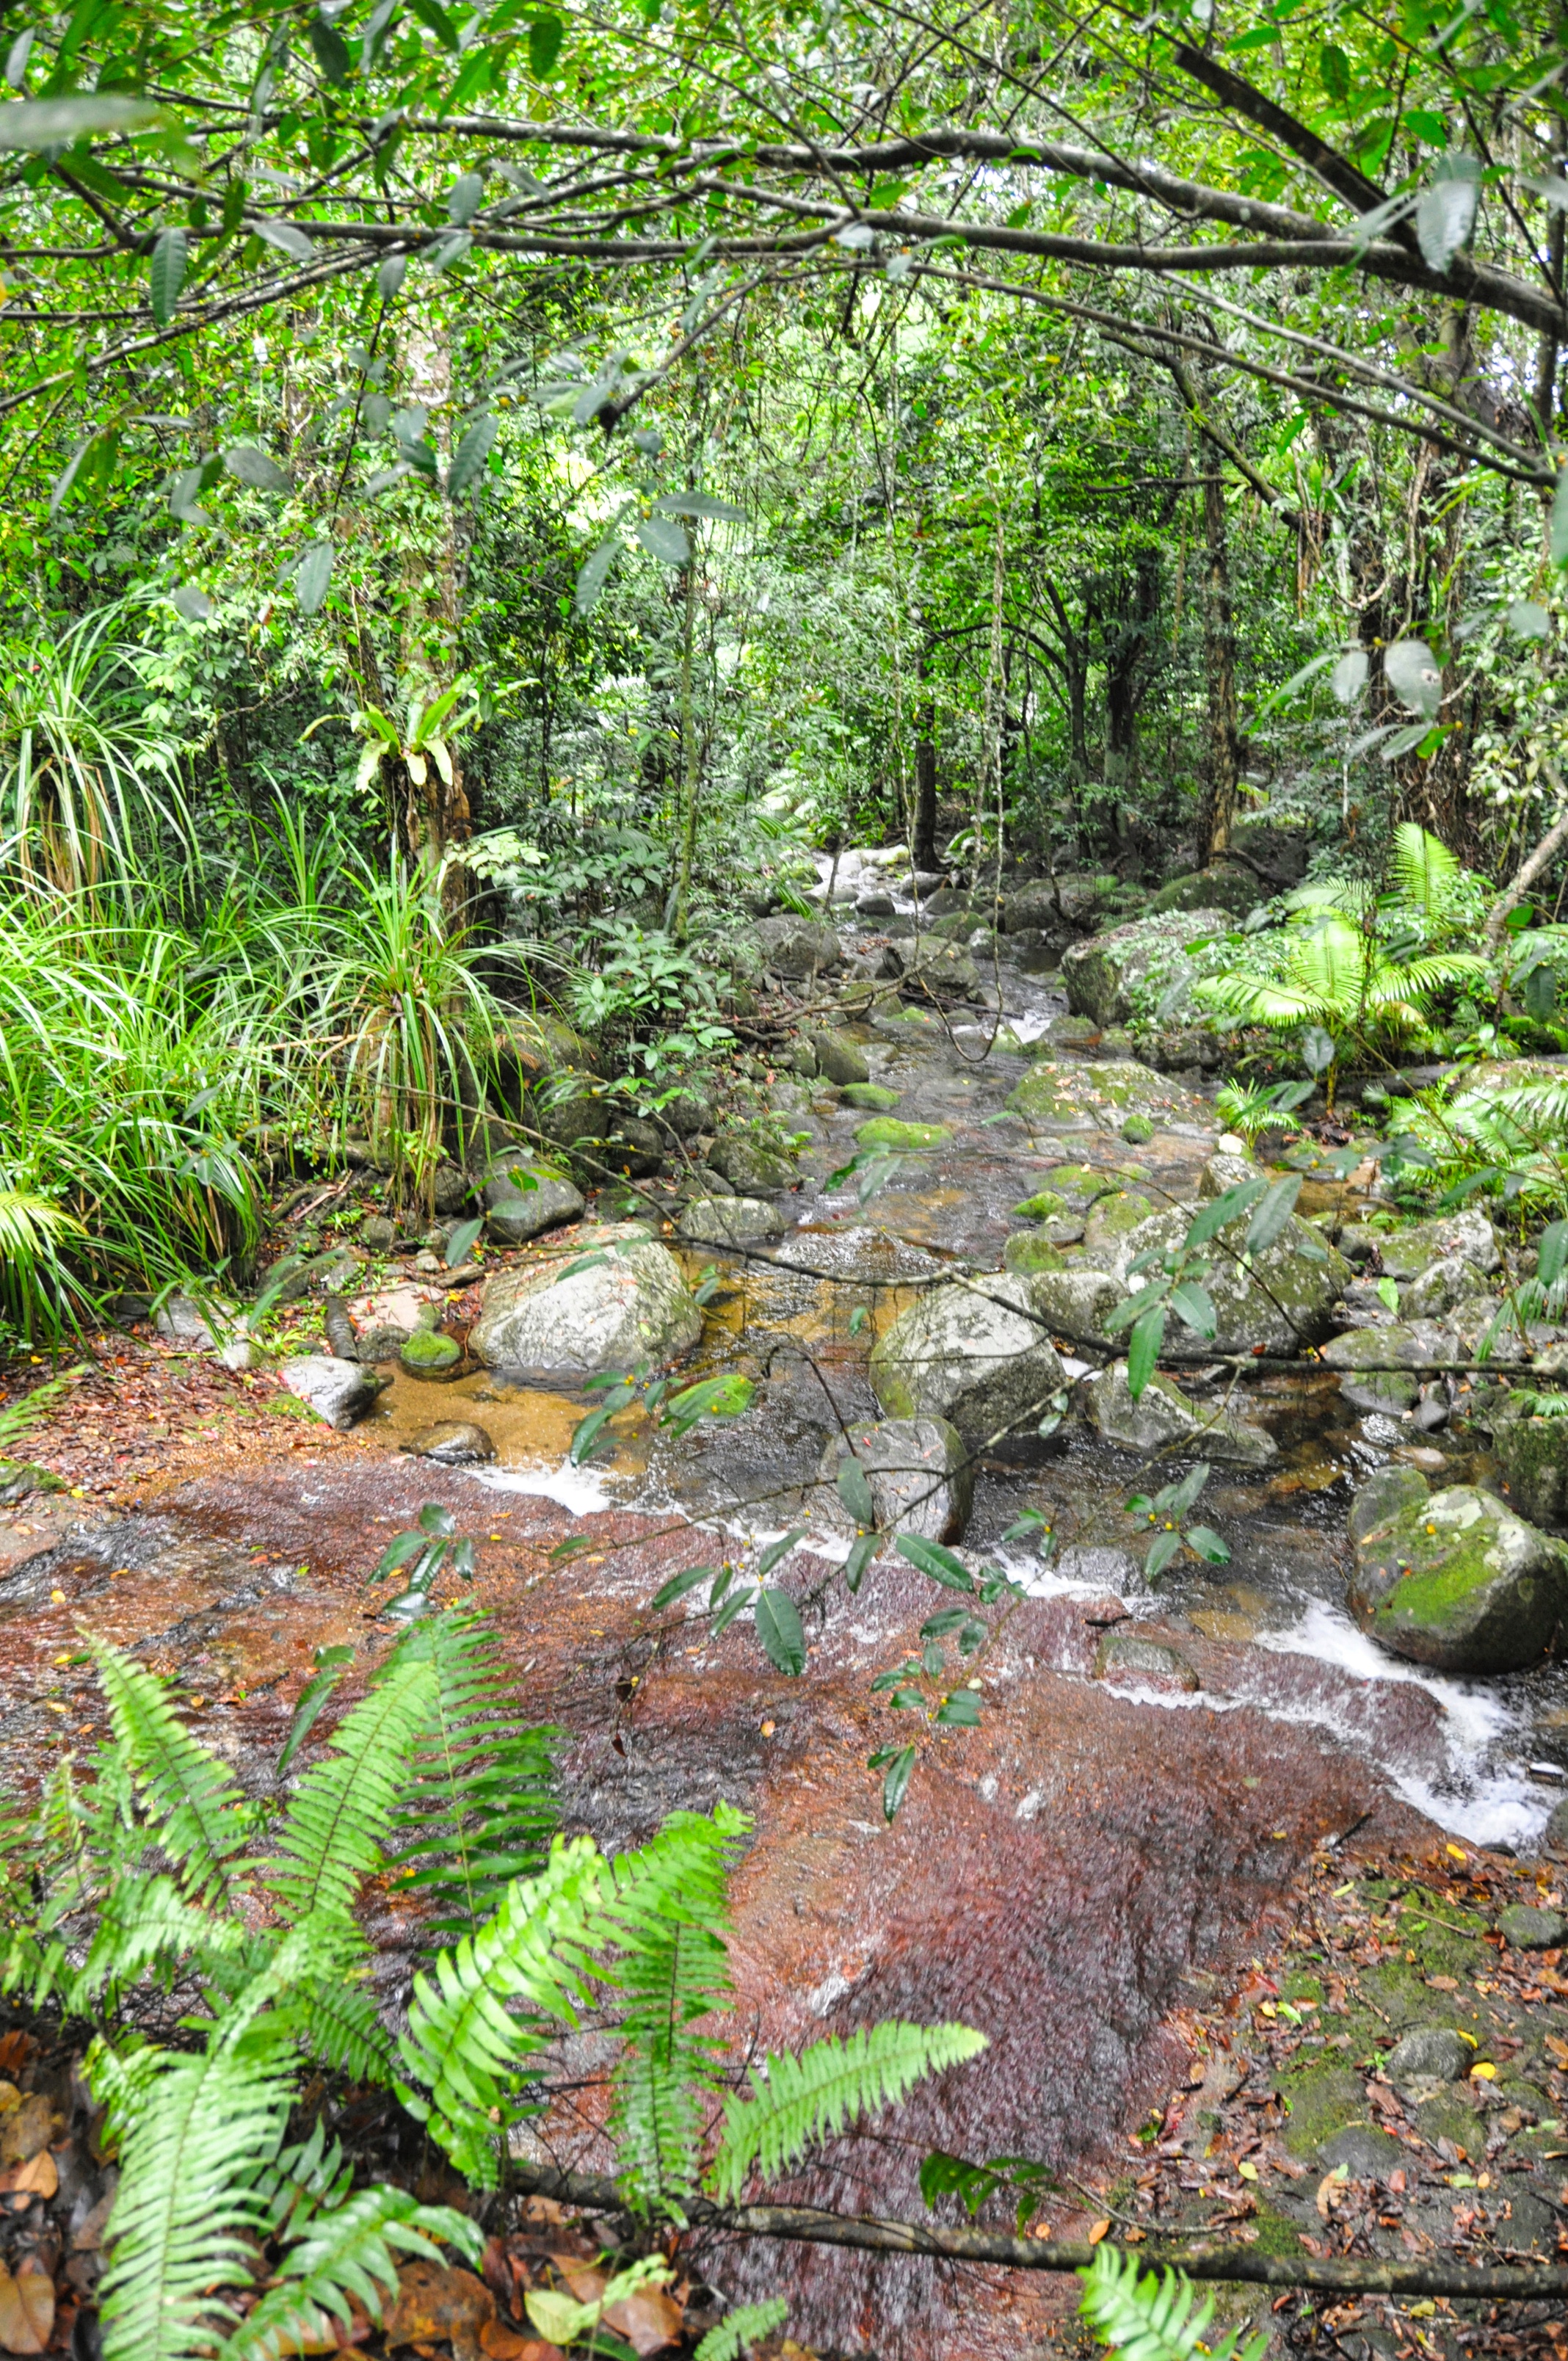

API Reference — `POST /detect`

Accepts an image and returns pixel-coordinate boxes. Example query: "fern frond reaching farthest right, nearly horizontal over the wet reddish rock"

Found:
[708,2019,987,2203]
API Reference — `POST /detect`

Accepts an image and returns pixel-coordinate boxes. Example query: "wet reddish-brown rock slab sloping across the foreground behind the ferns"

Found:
[0,1454,1422,2361]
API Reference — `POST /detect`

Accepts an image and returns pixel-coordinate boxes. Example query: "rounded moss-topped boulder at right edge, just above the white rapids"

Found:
[1351,1485,1568,1674]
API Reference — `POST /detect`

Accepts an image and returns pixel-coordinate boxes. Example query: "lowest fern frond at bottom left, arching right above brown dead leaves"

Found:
[217,2186,484,2361]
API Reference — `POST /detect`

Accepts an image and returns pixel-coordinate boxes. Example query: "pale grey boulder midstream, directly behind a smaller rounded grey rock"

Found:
[871,1272,1067,1445]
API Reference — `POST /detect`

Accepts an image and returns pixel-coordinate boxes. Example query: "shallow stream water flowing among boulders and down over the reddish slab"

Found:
[0,911,1568,2361]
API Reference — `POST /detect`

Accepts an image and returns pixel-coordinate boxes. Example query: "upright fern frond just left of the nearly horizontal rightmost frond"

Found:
[600,1804,747,2212]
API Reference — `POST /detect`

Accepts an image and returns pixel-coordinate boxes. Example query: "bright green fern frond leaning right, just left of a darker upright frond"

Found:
[264,1648,435,1922]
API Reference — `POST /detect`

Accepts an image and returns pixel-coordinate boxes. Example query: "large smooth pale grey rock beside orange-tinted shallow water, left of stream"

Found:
[470,1237,701,1377]
